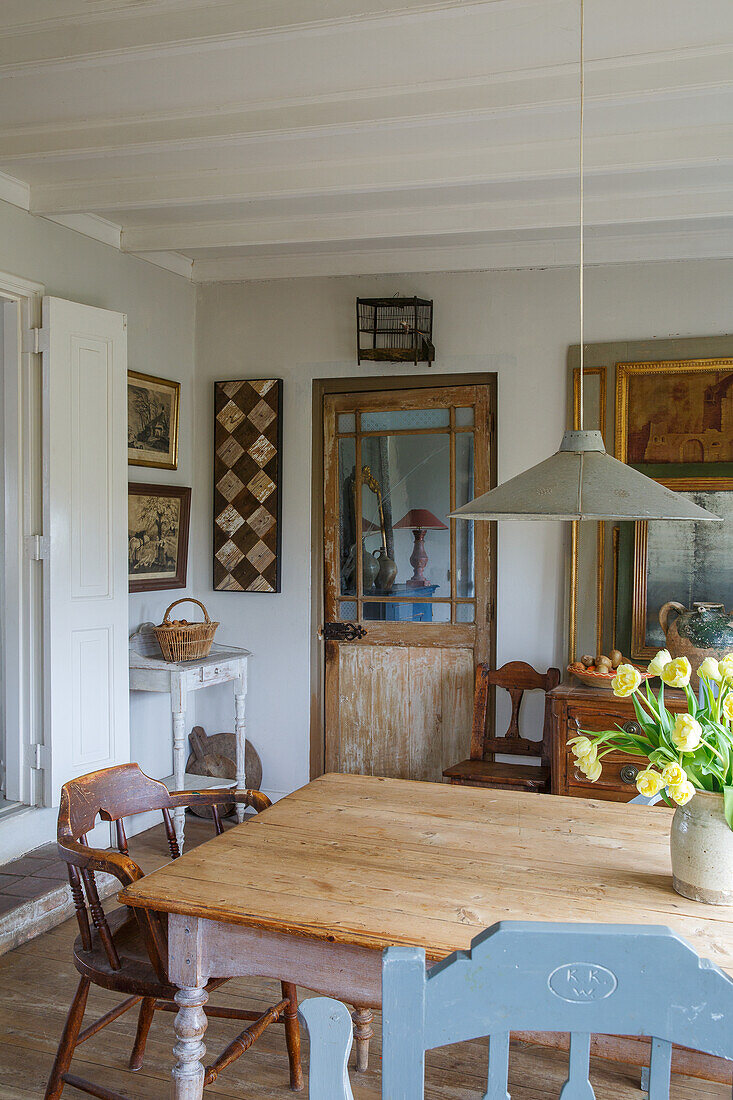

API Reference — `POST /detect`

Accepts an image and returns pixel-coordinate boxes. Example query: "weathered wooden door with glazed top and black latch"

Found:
[324,384,493,780]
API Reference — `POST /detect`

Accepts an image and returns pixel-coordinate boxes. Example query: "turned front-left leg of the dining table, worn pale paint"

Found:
[168,913,209,1100]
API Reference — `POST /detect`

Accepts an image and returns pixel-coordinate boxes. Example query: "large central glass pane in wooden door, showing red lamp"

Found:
[361,432,450,597]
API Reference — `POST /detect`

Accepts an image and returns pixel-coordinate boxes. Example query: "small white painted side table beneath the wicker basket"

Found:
[130,623,251,851]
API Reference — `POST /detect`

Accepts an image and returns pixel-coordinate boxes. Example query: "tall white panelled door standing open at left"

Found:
[41,297,130,805]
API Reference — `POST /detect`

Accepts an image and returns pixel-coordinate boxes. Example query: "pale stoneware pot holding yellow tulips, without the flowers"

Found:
[669,791,733,905]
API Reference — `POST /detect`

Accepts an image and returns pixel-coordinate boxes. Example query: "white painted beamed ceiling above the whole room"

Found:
[0,0,733,282]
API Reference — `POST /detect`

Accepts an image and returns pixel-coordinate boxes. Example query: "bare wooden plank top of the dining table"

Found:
[120,774,733,974]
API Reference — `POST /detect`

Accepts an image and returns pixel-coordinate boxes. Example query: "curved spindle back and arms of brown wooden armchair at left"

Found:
[57,763,270,982]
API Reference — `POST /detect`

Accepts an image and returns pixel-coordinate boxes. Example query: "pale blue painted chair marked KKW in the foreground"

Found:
[300,922,733,1100]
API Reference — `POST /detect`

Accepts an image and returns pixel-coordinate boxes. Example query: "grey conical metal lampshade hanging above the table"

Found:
[450,431,720,523]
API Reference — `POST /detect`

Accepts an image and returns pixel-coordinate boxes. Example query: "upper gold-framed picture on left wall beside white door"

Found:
[128,371,180,470]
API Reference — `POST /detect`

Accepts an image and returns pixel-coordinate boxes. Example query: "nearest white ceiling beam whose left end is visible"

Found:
[28,125,733,220]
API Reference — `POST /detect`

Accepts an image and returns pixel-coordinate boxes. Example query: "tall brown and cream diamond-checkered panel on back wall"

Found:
[214,378,283,592]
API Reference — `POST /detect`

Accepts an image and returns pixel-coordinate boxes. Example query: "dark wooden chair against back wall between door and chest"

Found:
[442,661,560,793]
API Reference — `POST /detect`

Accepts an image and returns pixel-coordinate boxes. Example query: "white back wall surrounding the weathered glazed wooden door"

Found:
[192,261,733,792]
